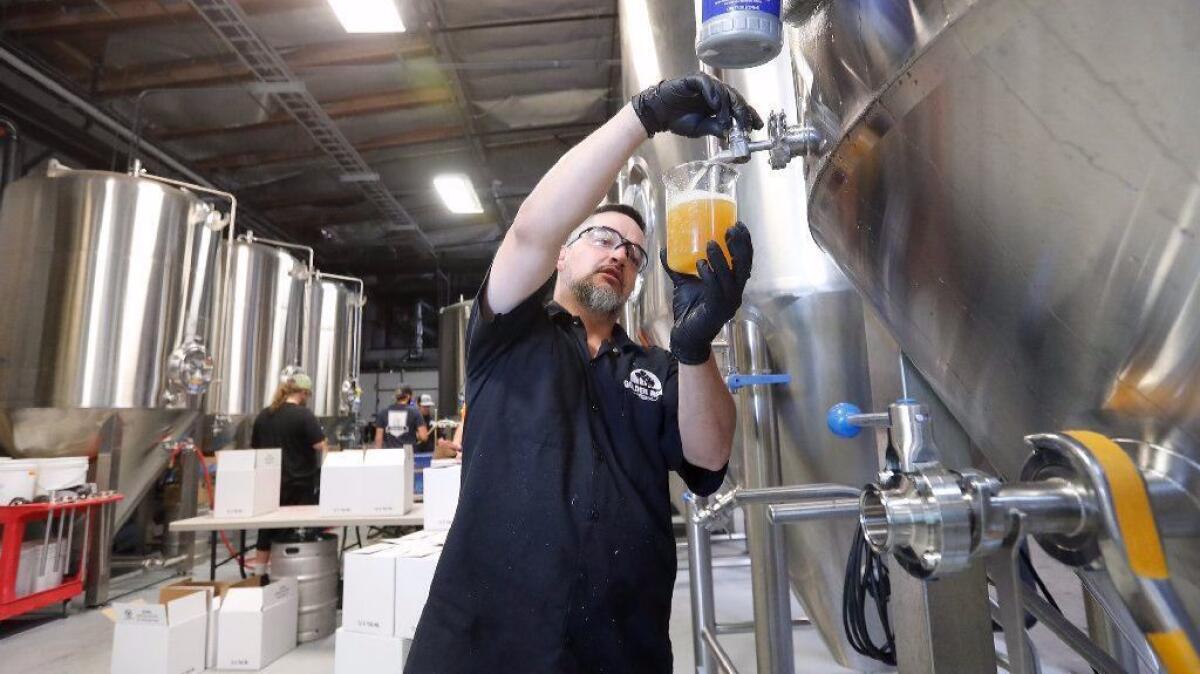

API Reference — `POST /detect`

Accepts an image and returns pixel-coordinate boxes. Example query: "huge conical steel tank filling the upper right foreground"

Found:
[787,0,1200,619]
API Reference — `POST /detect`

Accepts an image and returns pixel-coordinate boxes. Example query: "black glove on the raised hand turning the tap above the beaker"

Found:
[630,73,762,138]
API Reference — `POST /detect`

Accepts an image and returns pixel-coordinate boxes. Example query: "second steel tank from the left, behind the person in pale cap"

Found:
[206,240,307,450]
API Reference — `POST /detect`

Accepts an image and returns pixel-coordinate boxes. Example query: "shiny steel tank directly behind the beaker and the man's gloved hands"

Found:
[619,0,878,669]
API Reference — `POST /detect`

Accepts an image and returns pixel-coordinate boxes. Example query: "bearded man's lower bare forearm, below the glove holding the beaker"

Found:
[679,356,737,470]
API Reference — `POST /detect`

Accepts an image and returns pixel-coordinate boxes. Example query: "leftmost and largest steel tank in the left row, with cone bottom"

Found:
[0,163,221,523]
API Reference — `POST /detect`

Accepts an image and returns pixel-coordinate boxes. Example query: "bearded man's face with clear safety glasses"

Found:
[558,212,646,313]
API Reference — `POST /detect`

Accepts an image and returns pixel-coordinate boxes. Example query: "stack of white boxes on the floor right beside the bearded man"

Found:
[334,531,445,674]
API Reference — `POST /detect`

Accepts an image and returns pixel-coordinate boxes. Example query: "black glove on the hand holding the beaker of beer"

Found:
[659,222,754,365]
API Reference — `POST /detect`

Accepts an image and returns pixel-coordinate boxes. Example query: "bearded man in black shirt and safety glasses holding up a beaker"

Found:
[406,74,762,674]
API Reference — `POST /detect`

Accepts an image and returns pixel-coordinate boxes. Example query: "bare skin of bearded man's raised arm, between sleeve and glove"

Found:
[486,106,647,313]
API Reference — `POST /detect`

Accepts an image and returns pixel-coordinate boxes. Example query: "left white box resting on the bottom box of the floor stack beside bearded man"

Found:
[342,543,400,637]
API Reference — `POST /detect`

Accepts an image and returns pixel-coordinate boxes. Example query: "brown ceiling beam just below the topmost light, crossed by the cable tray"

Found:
[92,36,432,98]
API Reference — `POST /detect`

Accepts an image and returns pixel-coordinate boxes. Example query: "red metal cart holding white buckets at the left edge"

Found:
[0,486,124,620]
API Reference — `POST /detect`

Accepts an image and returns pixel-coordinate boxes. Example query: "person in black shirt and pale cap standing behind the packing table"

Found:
[250,373,325,576]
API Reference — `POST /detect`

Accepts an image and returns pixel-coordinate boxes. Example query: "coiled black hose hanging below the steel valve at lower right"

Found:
[841,524,896,666]
